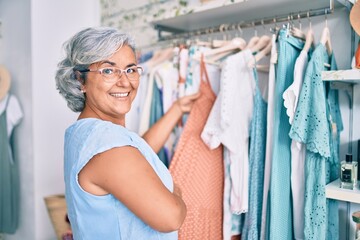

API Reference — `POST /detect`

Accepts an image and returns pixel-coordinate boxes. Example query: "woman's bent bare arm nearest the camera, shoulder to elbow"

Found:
[79,146,186,232]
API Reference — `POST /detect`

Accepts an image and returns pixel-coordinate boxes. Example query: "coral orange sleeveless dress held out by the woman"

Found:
[169,55,224,240]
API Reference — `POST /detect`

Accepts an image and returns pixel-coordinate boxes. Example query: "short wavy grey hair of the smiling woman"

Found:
[55,27,135,112]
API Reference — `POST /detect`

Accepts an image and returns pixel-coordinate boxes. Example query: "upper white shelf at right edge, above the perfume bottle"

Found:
[321,69,360,83]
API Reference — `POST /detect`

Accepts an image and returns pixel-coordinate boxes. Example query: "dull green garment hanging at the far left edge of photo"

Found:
[0,97,20,234]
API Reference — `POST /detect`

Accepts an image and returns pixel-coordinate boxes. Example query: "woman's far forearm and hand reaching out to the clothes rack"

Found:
[143,93,200,152]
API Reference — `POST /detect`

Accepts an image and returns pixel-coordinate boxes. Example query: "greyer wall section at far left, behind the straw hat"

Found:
[0,0,35,240]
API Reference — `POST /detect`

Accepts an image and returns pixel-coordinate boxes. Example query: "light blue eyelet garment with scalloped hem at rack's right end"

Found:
[289,44,343,240]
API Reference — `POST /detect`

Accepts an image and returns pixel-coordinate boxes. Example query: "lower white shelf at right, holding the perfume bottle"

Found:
[325,179,360,203]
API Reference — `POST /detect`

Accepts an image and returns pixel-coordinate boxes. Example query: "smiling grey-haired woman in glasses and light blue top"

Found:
[56,27,199,240]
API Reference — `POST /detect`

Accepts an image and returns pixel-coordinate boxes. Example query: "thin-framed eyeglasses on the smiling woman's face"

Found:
[79,66,143,83]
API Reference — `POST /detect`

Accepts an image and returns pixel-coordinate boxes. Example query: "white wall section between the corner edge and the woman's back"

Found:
[31,0,100,240]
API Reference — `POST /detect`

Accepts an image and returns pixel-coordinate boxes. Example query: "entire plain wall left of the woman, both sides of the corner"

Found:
[0,0,100,240]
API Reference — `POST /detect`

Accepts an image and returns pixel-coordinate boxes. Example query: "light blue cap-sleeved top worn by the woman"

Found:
[64,118,177,240]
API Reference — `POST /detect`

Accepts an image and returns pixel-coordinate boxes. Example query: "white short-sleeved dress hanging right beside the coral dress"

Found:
[201,50,255,239]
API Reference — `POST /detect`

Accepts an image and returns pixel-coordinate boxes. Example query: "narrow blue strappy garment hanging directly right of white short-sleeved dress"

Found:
[241,68,267,240]
